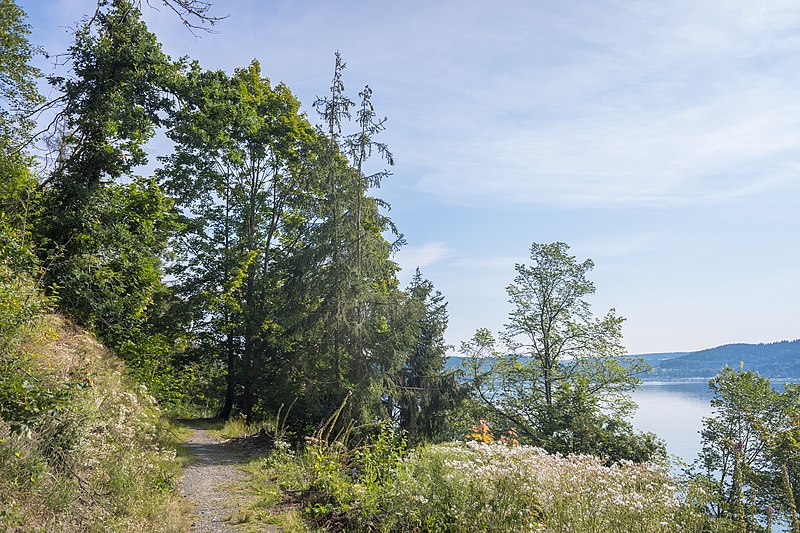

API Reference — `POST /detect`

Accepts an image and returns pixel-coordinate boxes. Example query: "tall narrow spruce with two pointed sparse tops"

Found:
[298,53,405,428]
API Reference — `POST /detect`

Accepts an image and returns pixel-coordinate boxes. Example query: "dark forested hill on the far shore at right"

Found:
[647,339,800,379]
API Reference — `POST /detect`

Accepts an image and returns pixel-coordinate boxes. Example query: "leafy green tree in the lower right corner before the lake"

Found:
[692,367,800,530]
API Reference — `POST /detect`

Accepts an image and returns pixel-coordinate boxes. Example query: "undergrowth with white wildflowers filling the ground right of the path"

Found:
[233,404,704,533]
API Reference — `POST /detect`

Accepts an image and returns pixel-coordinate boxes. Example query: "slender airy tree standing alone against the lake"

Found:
[462,242,662,460]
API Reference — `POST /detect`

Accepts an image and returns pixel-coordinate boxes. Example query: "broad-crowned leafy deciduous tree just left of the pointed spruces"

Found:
[160,61,315,418]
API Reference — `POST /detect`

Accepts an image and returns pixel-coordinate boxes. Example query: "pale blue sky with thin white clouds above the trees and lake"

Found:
[17,0,800,353]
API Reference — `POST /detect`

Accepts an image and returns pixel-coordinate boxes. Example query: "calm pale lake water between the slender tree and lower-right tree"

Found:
[632,381,712,463]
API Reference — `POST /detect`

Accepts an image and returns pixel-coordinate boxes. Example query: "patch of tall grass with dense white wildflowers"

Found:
[389,442,702,533]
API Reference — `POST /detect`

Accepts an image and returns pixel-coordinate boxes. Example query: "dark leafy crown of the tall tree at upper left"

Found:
[50,0,175,197]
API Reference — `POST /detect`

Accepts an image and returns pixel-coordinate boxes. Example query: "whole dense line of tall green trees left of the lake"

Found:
[1,0,460,438]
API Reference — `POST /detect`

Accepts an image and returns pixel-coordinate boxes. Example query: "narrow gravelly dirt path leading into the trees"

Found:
[182,420,253,533]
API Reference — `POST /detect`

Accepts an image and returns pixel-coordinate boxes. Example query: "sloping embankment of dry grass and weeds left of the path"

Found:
[0,315,189,532]
